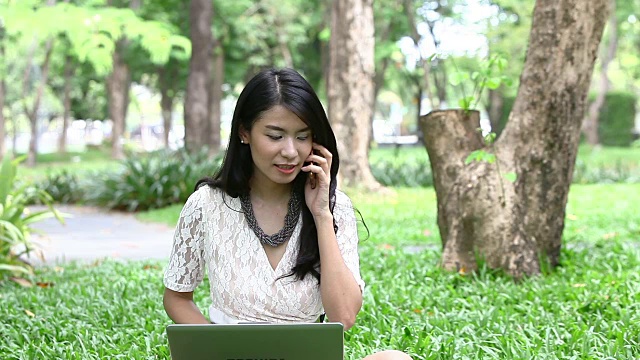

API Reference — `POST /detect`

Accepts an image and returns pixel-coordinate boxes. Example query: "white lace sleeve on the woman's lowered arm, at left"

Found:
[164,186,208,292]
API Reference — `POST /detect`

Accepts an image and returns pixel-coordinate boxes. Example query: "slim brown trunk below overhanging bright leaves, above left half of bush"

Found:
[107,38,131,159]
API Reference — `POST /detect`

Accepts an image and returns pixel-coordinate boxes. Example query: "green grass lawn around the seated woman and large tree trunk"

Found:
[0,184,640,359]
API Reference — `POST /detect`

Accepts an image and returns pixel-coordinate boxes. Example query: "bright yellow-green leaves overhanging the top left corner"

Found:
[0,2,191,75]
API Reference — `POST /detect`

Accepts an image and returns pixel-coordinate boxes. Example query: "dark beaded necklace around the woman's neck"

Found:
[240,191,300,247]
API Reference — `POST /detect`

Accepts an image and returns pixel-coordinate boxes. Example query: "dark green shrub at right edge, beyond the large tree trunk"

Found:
[598,92,638,146]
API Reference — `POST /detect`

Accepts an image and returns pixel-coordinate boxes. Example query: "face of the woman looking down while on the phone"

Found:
[240,105,313,190]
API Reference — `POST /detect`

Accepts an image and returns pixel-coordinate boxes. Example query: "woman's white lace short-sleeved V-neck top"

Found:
[164,186,364,324]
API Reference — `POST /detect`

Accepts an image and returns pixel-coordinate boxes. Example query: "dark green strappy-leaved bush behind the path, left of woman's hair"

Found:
[85,149,222,211]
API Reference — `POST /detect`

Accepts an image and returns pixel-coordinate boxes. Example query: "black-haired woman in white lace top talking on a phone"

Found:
[164,69,409,360]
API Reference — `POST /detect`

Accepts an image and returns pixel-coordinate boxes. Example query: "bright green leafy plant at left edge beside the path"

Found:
[0,156,62,280]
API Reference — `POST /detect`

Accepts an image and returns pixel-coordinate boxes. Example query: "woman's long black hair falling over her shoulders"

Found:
[196,68,340,283]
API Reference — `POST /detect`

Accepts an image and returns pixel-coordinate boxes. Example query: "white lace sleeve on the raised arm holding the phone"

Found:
[333,191,364,292]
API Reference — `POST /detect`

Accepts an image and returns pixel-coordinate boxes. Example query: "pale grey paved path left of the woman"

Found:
[29,205,173,264]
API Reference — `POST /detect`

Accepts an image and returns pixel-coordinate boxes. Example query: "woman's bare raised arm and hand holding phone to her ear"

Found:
[302,143,362,330]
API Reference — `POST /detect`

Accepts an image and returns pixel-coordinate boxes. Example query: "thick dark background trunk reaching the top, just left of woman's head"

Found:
[184,0,213,152]
